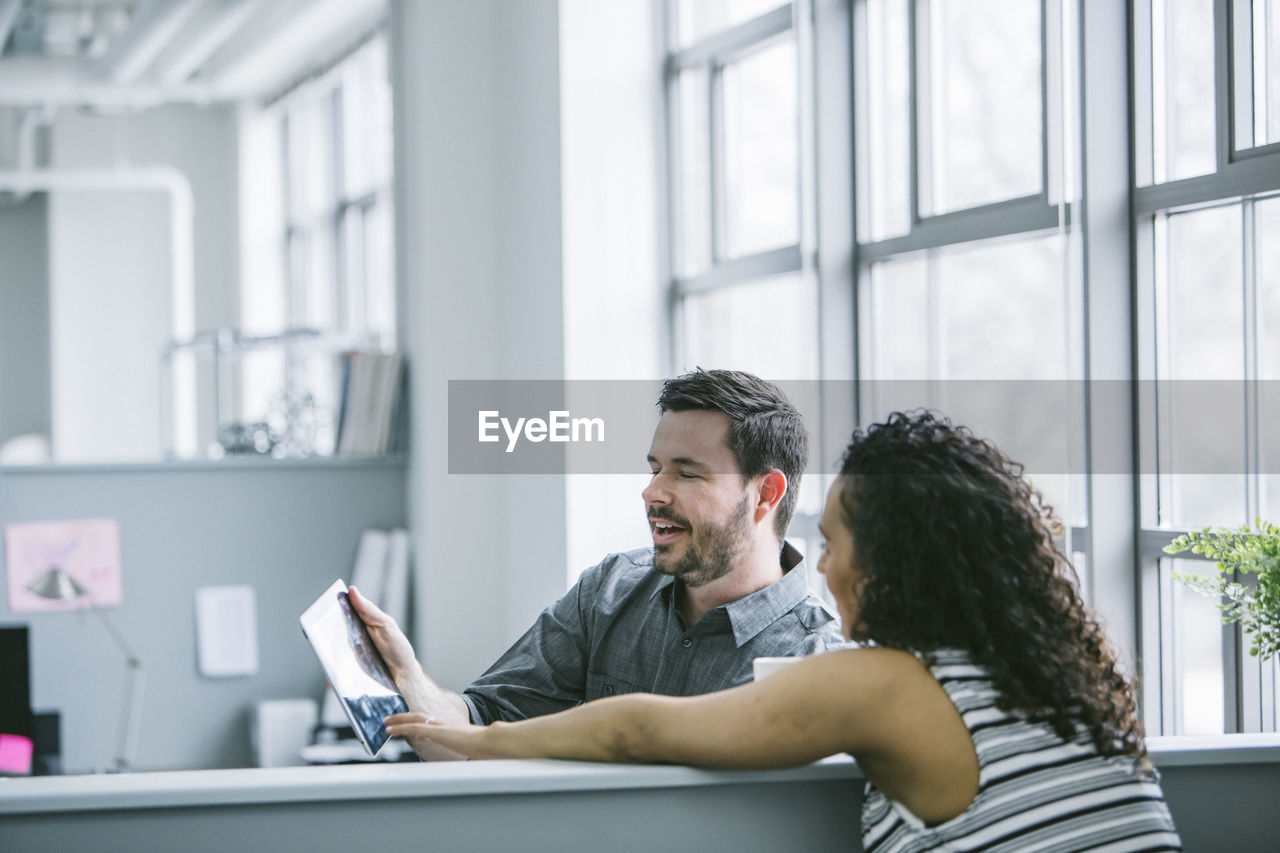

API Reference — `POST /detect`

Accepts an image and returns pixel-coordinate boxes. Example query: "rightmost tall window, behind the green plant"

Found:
[1133,0,1280,734]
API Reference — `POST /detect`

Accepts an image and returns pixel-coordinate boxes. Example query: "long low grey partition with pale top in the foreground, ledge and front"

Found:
[0,734,1280,853]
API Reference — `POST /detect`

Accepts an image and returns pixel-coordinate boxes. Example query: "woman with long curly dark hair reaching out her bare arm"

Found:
[388,412,1180,850]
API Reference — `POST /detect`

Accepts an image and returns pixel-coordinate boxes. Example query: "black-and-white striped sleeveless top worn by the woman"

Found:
[863,649,1181,853]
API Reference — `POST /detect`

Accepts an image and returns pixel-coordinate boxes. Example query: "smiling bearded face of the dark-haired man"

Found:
[641,411,754,587]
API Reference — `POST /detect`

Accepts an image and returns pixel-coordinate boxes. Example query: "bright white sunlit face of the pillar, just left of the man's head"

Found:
[559,0,671,580]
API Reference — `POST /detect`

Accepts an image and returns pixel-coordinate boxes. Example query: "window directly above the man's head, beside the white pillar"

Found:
[667,0,818,379]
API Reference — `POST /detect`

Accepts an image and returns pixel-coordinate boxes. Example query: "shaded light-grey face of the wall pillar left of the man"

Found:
[390,0,566,689]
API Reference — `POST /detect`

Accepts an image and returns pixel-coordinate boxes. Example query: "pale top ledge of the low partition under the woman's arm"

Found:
[0,734,1280,815]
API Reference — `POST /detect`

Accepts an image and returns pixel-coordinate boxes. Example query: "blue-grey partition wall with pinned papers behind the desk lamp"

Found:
[0,462,406,772]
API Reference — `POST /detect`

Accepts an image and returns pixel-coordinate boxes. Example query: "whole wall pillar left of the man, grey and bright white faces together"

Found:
[390,0,668,689]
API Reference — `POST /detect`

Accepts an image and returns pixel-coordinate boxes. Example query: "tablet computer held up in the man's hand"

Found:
[302,579,408,756]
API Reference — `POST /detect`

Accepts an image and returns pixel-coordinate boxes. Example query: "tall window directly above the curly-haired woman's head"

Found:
[854,0,1087,537]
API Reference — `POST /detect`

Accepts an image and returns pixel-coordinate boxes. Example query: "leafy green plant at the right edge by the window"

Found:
[1165,519,1280,658]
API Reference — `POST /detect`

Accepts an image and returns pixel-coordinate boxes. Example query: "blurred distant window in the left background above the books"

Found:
[235,35,396,453]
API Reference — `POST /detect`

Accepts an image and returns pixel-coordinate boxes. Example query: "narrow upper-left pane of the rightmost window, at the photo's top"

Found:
[1151,0,1217,183]
